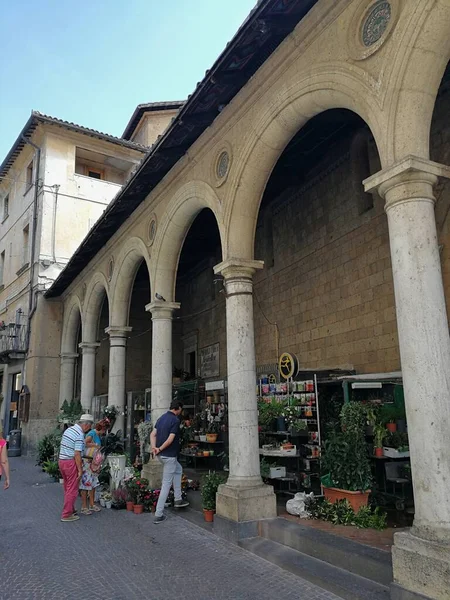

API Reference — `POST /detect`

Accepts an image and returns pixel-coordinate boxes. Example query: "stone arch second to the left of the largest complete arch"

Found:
[110,237,152,325]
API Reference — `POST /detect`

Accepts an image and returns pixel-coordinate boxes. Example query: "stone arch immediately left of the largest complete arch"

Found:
[153,181,224,301]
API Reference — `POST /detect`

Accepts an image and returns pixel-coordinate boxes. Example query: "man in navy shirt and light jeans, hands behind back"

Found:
[150,400,189,523]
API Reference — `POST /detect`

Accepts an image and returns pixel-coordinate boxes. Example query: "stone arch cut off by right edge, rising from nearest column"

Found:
[387,0,450,164]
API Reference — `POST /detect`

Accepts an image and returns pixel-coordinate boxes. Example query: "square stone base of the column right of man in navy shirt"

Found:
[216,483,277,523]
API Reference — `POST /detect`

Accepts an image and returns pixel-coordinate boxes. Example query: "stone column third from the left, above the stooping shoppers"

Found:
[105,326,132,436]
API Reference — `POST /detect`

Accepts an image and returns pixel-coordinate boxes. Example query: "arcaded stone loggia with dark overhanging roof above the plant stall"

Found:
[20,0,450,600]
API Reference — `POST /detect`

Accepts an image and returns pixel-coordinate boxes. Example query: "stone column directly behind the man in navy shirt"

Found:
[142,300,180,488]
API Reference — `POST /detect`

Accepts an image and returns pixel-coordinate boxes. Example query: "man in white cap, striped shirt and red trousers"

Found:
[58,414,94,522]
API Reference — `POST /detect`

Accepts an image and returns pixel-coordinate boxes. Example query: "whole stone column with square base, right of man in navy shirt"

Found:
[214,259,276,537]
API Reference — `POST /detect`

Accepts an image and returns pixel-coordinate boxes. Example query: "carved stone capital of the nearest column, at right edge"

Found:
[363,155,450,209]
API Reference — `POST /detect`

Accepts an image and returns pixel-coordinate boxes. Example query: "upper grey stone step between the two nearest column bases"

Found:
[258,518,393,586]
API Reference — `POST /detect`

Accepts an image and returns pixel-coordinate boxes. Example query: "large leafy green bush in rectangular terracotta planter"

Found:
[321,402,372,512]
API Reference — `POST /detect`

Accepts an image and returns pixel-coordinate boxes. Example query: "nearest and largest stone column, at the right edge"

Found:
[364,156,450,600]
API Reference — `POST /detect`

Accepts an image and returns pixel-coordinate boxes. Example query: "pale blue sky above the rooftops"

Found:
[0,0,256,163]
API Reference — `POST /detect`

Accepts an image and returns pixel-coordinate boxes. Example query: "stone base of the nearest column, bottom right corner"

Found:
[391,531,450,600]
